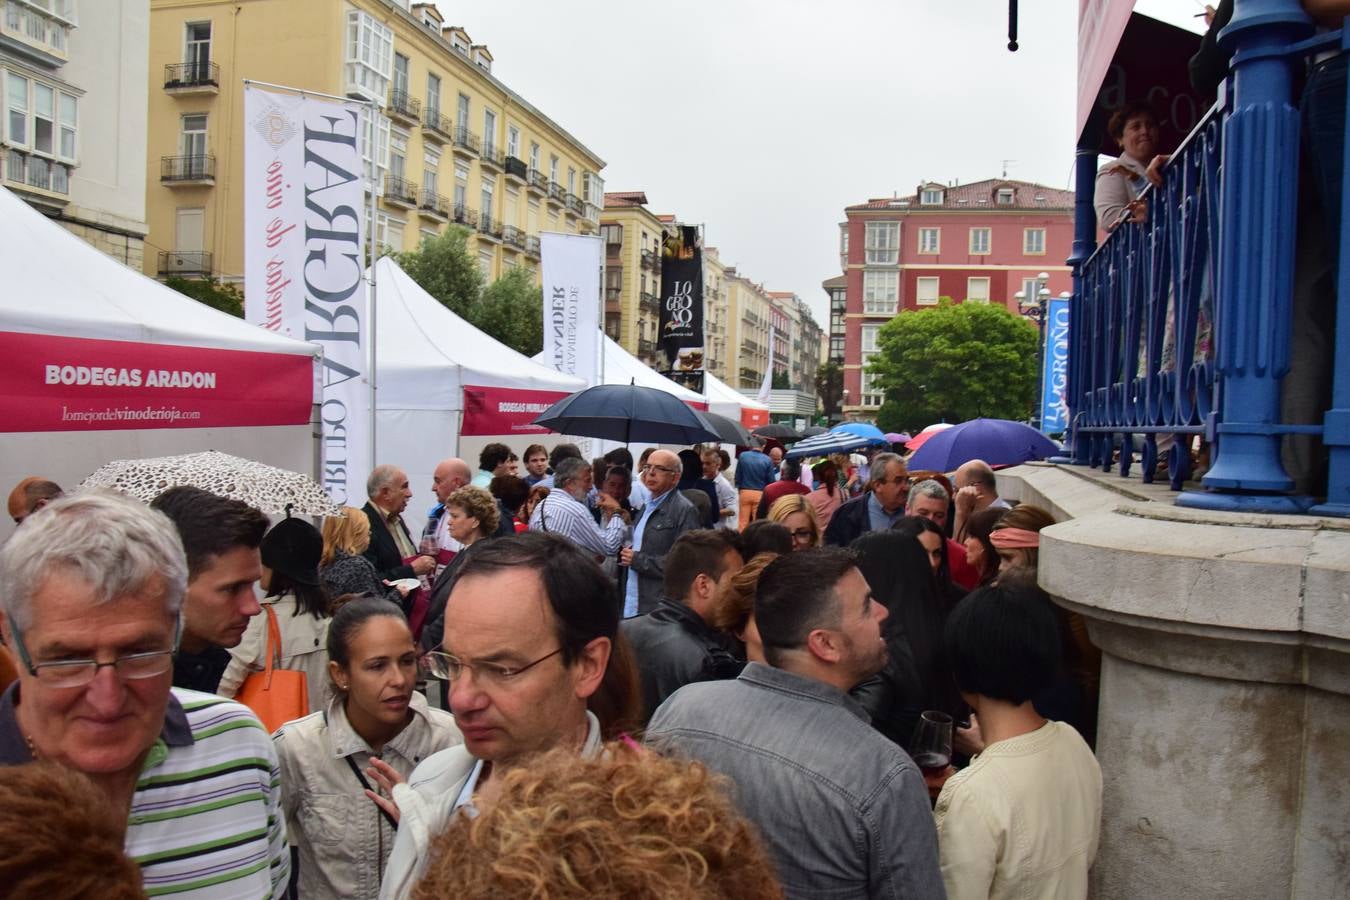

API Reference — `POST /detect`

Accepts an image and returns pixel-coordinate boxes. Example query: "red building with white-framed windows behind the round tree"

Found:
[840,178,1073,417]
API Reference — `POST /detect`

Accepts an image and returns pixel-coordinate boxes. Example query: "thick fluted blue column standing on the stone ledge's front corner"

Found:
[1177,0,1312,513]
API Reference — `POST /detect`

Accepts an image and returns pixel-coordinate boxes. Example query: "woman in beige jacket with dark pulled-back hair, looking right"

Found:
[273,595,462,900]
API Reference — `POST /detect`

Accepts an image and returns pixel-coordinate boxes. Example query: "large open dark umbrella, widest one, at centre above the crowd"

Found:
[535,385,721,444]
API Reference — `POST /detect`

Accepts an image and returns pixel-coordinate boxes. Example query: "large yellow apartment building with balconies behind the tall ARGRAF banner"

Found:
[143,0,605,281]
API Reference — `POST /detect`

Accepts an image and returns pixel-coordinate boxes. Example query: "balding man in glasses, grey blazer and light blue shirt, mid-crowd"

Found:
[618,449,702,618]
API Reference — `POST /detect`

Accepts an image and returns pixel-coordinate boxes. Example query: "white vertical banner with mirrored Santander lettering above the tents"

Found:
[539,232,603,387]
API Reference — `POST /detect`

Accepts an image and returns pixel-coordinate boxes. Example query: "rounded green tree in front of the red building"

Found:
[868,297,1037,432]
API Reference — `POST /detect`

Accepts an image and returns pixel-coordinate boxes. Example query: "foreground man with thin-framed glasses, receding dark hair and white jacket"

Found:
[370,532,621,900]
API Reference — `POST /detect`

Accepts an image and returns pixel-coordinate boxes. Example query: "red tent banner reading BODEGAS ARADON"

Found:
[0,332,315,432]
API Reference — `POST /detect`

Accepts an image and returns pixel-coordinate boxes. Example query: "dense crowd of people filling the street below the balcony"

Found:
[0,443,1102,899]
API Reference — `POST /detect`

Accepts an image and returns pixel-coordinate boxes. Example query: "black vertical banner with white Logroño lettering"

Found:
[660,225,705,393]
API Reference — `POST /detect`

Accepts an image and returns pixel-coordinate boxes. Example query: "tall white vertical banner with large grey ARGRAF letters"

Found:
[244,85,374,506]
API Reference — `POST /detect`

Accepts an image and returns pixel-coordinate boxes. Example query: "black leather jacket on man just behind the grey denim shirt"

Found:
[618,598,745,722]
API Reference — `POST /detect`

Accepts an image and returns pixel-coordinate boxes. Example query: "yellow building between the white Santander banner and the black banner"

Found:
[599,190,666,368]
